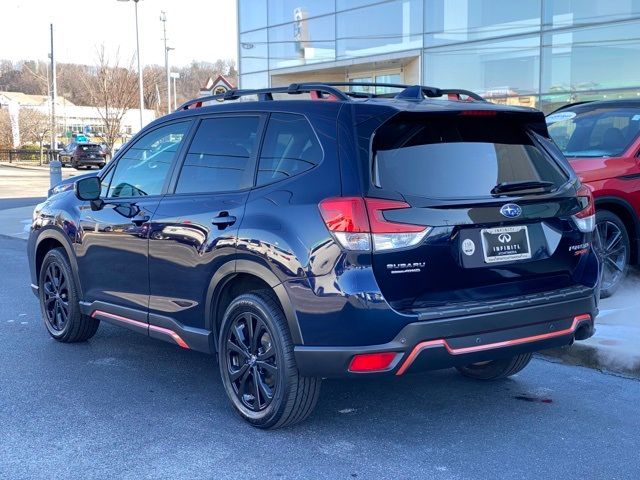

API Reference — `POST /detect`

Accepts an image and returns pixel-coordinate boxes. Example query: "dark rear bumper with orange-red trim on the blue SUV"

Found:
[295,295,597,377]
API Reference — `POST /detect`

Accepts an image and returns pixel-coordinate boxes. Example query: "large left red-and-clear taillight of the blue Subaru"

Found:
[319,197,431,251]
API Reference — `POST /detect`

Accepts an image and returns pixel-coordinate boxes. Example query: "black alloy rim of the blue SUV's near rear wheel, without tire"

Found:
[226,312,278,412]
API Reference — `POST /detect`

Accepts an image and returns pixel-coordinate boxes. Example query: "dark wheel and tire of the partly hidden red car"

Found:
[593,210,631,298]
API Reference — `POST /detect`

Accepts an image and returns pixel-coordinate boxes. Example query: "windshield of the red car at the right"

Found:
[547,108,640,157]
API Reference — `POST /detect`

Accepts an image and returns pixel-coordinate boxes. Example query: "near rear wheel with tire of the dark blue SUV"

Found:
[218,290,322,429]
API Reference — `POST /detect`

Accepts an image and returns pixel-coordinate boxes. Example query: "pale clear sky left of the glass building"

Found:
[0,0,237,66]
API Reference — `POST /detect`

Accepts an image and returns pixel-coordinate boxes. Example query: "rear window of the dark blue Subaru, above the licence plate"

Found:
[372,116,568,199]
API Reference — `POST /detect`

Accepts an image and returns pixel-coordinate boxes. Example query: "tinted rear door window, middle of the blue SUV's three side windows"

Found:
[176,117,260,193]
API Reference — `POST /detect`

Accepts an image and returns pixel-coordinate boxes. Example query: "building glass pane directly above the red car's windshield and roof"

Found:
[542,22,640,98]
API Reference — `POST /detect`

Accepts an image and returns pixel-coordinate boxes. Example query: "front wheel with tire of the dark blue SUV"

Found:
[38,248,100,343]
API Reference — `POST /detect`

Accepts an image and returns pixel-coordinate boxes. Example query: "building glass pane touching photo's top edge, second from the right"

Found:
[425,0,540,46]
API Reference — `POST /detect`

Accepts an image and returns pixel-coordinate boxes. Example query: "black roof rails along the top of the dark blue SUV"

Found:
[177,82,485,110]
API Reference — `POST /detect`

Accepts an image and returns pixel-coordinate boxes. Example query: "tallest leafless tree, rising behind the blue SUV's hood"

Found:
[83,45,138,156]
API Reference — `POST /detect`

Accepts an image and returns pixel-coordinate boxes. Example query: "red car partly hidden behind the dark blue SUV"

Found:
[547,100,640,297]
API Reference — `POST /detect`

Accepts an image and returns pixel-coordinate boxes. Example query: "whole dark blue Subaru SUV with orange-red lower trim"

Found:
[28,84,599,428]
